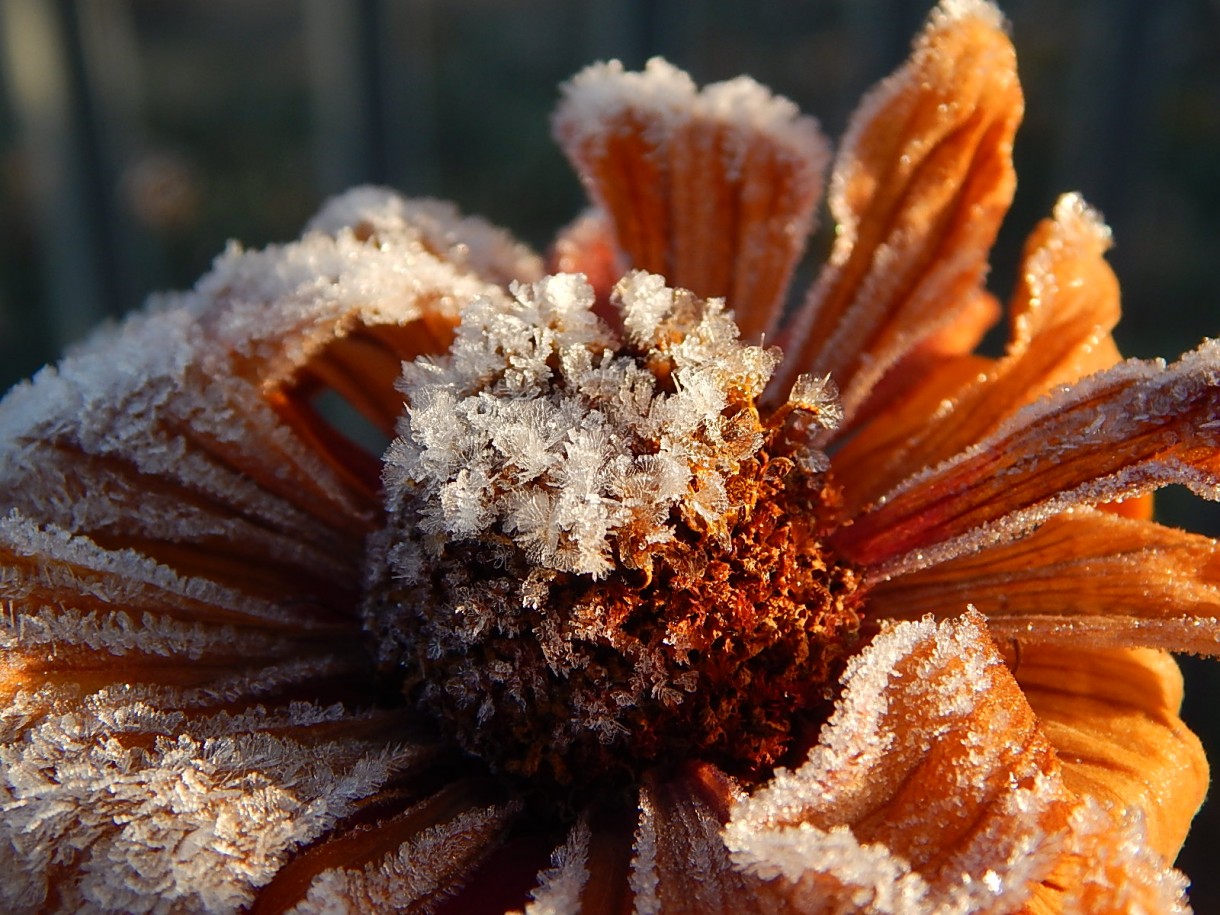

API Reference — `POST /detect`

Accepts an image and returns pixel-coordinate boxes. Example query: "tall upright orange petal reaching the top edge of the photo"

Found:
[772,2,1022,420]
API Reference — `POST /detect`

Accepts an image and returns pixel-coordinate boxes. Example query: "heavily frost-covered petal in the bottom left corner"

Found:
[0,687,429,913]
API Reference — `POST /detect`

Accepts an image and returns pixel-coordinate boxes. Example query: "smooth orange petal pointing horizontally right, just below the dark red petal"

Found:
[869,509,1220,654]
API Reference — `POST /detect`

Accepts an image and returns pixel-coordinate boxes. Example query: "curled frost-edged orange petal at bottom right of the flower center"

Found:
[725,614,1074,913]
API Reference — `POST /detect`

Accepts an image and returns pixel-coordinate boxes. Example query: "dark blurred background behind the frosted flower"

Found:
[0,0,1220,913]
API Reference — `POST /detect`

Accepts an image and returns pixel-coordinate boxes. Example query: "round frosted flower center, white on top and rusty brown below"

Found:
[365,272,860,783]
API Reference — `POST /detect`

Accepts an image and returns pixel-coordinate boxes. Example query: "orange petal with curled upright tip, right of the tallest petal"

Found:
[836,195,1119,511]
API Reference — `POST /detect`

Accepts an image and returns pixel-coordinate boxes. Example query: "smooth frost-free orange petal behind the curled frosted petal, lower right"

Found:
[1016,647,1208,861]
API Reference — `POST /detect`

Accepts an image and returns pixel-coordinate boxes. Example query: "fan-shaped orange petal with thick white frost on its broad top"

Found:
[554,60,828,340]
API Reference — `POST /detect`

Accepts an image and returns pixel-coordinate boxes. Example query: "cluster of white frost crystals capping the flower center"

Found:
[384,272,776,577]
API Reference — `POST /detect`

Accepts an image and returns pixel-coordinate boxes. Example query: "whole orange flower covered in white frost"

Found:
[0,0,1220,913]
